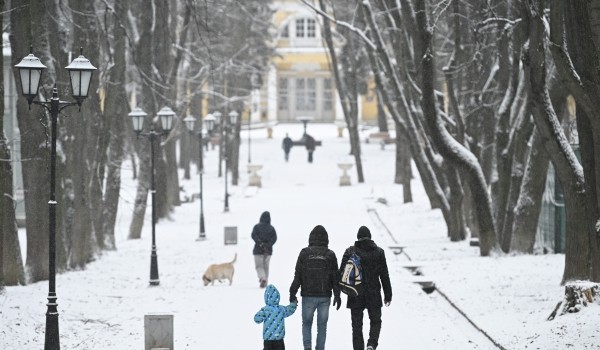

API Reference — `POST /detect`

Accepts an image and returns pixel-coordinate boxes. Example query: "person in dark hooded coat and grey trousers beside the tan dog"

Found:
[252,211,277,288]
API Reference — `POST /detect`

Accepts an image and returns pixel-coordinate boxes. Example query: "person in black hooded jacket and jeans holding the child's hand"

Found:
[290,225,342,350]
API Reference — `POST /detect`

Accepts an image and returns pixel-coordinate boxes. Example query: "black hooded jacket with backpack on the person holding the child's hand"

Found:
[290,225,340,297]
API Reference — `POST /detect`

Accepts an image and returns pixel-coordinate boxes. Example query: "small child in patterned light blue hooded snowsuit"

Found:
[254,284,298,350]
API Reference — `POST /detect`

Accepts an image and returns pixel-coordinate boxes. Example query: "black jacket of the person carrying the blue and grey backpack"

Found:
[340,238,392,309]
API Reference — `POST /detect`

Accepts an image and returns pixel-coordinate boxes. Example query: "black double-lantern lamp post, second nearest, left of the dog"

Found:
[128,107,175,286]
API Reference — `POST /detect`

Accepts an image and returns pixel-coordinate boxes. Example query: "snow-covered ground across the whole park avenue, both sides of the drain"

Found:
[0,124,600,350]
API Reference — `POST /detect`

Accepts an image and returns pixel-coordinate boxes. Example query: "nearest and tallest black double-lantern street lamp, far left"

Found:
[15,49,96,350]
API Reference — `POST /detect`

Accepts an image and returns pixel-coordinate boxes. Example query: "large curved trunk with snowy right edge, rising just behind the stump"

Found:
[524,1,590,283]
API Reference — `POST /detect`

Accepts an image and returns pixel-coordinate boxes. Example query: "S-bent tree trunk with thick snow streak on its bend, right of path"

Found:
[416,2,497,256]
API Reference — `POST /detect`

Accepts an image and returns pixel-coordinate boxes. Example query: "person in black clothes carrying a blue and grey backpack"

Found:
[340,226,392,350]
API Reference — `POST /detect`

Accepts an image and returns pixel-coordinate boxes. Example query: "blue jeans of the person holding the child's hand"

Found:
[302,297,331,350]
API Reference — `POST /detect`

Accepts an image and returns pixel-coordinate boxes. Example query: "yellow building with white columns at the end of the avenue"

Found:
[251,0,377,124]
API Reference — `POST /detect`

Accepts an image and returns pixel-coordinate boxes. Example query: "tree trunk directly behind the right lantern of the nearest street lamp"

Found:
[69,0,102,269]
